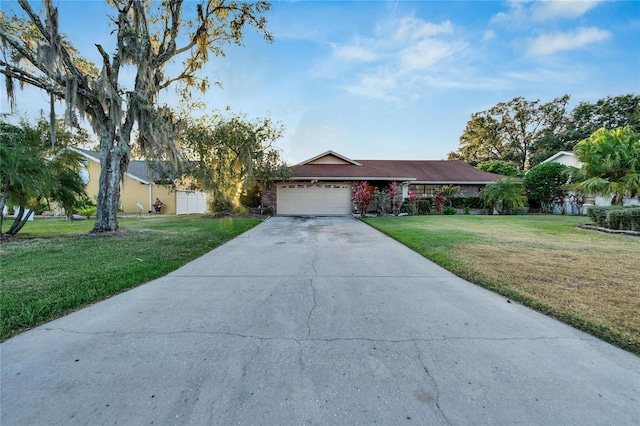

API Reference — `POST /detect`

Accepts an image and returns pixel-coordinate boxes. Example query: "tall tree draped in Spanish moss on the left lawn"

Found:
[0,0,272,232]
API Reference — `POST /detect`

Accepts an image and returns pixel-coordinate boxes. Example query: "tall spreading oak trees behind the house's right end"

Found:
[449,94,640,171]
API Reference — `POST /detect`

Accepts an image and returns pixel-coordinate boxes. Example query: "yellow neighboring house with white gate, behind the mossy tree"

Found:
[71,148,207,214]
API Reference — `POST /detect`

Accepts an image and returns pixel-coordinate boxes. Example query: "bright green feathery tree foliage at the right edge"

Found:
[569,127,640,205]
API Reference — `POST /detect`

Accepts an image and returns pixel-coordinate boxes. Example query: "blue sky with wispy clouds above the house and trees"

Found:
[0,0,640,164]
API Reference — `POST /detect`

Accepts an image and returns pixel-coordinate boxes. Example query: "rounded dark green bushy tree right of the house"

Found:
[522,162,567,213]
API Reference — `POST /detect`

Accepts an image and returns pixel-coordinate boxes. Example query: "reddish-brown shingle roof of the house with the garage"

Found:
[292,160,504,183]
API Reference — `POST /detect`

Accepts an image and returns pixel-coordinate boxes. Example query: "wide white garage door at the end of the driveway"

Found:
[277,182,351,216]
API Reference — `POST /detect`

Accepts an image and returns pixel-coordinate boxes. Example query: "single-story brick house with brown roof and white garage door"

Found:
[262,151,504,215]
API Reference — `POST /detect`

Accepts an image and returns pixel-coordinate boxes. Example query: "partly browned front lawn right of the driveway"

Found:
[365,215,640,355]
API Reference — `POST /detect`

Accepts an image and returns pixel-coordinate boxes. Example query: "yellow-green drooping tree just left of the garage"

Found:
[179,114,291,211]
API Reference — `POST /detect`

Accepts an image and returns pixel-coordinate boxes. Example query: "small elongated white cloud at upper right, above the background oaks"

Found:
[527,27,611,56]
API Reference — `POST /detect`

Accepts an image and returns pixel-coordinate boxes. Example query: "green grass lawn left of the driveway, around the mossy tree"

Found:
[0,216,260,340]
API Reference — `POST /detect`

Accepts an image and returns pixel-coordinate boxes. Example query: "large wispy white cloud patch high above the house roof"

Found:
[320,15,468,101]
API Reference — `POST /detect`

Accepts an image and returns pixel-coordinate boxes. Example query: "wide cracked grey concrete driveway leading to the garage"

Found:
[1,217,640,426]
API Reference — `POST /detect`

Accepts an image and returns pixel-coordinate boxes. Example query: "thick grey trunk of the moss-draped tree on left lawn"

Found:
[91,132,129,233]
